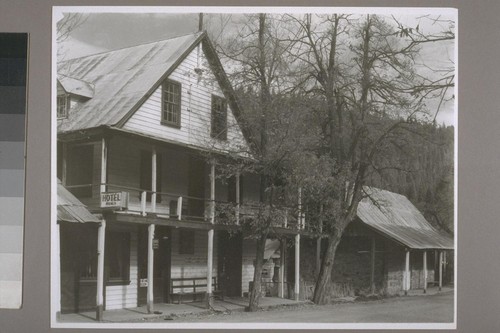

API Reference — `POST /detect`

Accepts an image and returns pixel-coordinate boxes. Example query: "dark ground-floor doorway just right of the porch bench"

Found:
[217,231,243,297]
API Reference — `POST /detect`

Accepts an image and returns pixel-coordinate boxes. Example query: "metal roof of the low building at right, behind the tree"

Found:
[358,187,454,249]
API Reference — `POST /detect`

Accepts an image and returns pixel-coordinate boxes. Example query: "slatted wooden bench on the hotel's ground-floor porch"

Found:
[170,276,224,304]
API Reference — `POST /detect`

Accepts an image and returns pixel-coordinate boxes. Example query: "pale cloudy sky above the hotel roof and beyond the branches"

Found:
[54,7,456,125]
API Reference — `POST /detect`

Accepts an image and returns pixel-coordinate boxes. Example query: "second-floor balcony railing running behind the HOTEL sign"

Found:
[66,183,306,230]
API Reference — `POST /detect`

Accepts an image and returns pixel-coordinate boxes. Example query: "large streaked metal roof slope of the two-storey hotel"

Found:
[58,33,203,133]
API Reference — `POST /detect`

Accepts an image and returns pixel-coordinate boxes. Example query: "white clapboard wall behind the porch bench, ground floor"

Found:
[171,229,217,290]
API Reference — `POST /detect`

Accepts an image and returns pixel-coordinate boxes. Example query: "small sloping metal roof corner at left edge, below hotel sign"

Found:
[57,182,101,223]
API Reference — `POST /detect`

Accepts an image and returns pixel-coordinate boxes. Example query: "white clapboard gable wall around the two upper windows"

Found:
[123,43,246,154]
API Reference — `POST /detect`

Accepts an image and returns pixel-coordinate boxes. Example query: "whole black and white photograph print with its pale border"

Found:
[50,6,458,329]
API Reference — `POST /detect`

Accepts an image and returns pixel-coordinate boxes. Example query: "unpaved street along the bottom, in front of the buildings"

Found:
[174,292,453,323]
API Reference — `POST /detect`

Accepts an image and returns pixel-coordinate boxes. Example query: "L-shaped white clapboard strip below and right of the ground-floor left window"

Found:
[106,232,137,310]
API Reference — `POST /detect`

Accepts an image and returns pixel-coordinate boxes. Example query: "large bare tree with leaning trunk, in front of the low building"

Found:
[288,14,452,303]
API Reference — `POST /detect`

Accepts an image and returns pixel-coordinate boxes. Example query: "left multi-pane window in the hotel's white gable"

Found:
[161,80,181,127]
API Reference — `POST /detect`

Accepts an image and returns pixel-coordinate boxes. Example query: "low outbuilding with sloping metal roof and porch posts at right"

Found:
[301,187,454,298]
